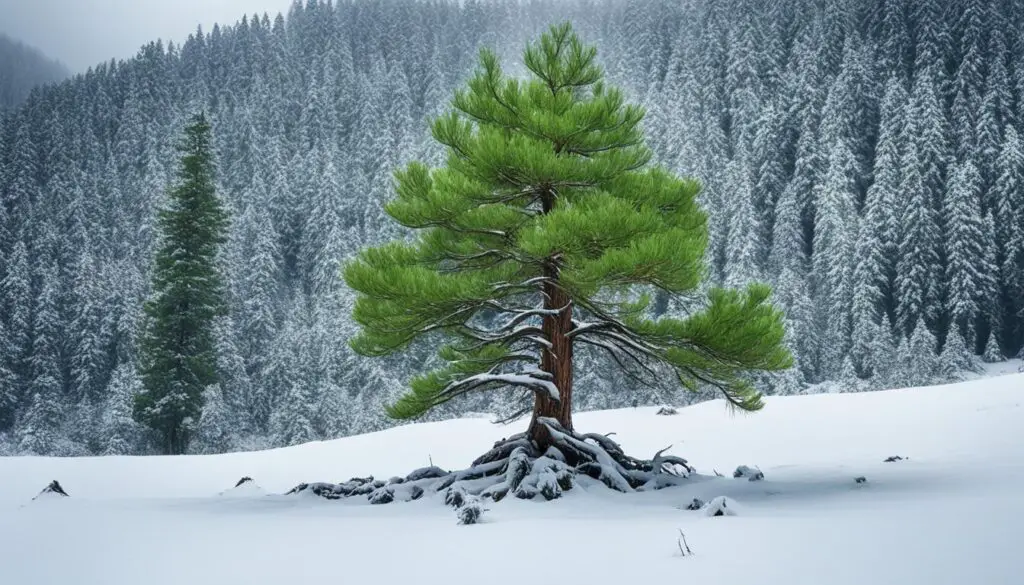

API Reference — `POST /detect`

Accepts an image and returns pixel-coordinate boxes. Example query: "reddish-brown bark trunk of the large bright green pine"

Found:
[527,192,572,451]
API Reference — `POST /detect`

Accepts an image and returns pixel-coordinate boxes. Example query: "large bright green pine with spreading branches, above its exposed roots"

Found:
[344,24,792,452]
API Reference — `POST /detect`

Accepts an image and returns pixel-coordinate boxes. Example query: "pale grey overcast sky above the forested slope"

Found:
[0,0,291,73]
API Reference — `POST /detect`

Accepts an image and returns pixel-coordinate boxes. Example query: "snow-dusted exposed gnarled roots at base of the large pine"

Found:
[288,418,694,507]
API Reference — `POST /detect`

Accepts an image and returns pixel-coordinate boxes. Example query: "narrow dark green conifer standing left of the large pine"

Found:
[133,114,228,454]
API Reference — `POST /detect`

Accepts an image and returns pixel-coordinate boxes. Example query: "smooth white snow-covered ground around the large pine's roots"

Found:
[0,374,1024,585]
